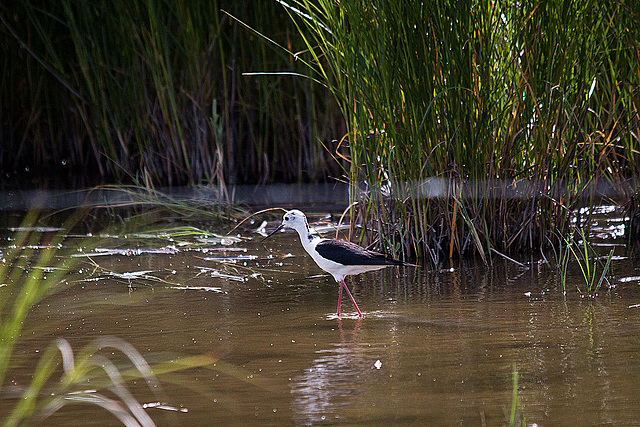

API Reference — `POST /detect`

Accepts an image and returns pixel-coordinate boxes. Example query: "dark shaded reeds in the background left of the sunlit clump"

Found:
[0,0,342,186]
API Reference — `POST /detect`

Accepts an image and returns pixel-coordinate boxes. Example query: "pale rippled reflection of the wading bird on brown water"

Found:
[291,317,364,424]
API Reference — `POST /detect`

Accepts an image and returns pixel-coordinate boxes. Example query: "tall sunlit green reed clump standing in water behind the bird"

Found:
[281,0,640,258]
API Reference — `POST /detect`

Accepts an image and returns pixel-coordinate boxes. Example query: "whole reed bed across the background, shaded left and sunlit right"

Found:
[0,0,640,263]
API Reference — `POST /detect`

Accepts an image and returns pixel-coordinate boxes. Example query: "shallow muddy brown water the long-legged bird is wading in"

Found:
[0,209,640,425]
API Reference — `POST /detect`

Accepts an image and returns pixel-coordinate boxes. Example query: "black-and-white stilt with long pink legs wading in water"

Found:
[262,209,412,317]
